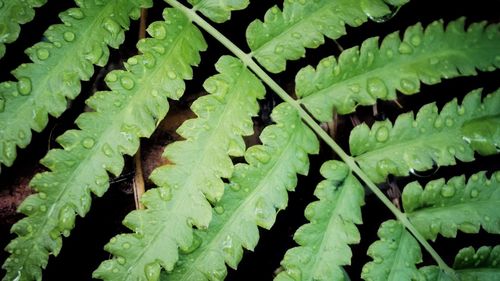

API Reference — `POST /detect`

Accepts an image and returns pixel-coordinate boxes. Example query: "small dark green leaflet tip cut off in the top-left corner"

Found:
[0,0,47,58]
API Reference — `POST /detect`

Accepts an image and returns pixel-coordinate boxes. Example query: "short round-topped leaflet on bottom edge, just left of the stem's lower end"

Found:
[361,220,425,281]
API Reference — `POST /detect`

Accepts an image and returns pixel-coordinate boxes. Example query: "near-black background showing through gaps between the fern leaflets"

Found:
[0,0,500,281]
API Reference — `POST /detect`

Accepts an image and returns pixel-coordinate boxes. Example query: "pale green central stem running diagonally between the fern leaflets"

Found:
[165,0,458,281]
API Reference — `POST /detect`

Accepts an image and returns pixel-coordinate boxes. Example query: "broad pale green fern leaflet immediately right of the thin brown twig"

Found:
[94,56,265,281]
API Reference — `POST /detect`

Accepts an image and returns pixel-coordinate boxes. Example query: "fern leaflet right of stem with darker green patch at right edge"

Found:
[349,90,500,183]
